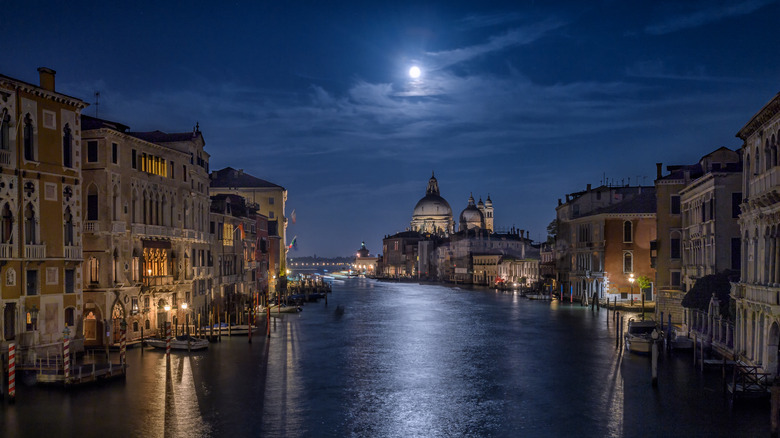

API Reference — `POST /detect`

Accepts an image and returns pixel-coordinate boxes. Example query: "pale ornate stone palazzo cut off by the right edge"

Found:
[731,90,780,376]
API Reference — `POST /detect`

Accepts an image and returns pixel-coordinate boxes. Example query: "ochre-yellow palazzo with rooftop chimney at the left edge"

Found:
[0,67,87,347]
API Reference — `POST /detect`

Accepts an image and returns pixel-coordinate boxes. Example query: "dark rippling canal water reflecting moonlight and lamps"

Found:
[0,279,769,437]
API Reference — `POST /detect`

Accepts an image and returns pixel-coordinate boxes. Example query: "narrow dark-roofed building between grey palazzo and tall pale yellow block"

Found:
[207,194,258,323]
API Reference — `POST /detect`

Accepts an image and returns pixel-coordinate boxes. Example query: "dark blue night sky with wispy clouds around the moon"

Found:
[6,0,780,256]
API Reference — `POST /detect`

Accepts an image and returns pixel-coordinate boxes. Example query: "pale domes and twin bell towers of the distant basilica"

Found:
[411,175,493,236]
